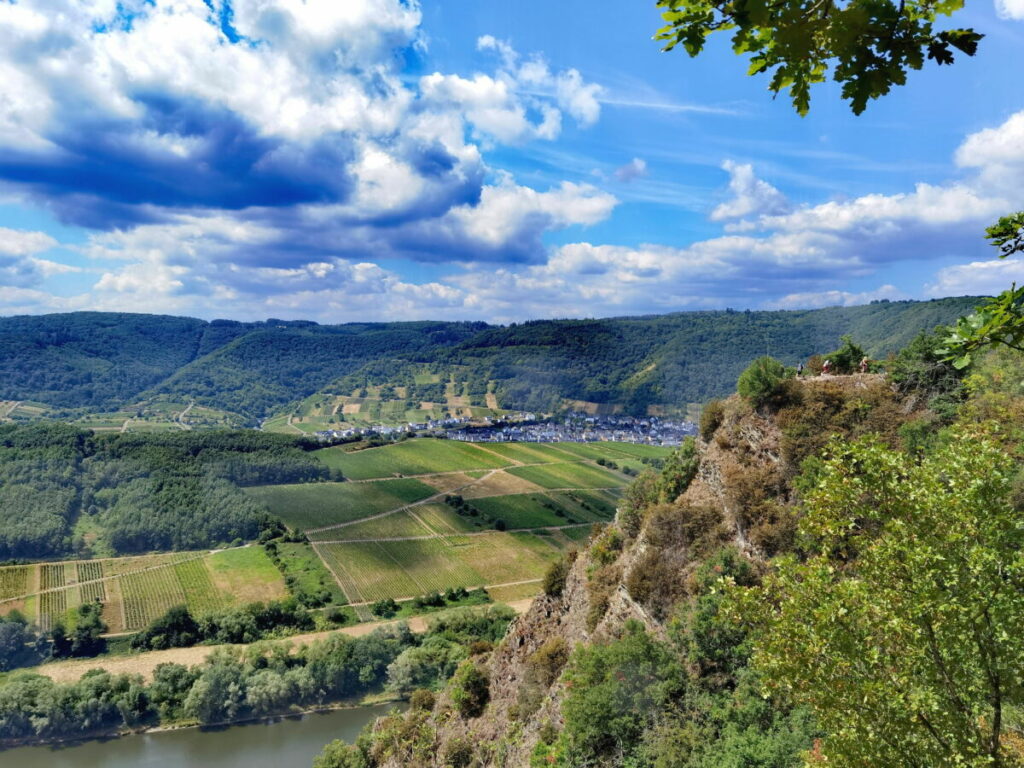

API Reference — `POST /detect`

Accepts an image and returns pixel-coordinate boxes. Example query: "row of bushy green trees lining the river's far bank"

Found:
[0,608,511,745]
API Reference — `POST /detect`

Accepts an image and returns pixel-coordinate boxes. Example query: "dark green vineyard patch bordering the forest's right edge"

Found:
[246,479,436,530]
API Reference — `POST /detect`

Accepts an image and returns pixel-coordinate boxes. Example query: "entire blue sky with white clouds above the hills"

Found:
[0,0,1024,322]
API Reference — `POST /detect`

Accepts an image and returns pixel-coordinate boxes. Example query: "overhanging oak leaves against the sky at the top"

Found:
[656,0,983,115]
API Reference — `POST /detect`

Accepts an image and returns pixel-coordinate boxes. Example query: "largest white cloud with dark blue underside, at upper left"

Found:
[0,0,607,272]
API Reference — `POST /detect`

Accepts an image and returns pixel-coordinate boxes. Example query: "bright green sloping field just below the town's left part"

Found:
[316,439,511,480]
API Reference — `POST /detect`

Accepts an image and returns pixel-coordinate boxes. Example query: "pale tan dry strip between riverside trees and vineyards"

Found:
[32,598,534,683]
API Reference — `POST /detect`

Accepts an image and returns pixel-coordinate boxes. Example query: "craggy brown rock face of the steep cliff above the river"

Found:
[386,376,915,768]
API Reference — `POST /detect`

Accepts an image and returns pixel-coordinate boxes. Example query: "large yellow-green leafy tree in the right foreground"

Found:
[732,430,1024,768]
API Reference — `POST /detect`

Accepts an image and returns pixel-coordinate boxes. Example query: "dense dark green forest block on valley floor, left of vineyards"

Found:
[0,423,331,557]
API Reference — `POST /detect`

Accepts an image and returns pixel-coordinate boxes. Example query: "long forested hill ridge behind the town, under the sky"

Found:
[0,297,978,428]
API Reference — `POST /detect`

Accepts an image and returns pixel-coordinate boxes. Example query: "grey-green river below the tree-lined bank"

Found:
[0,705,393,768]
